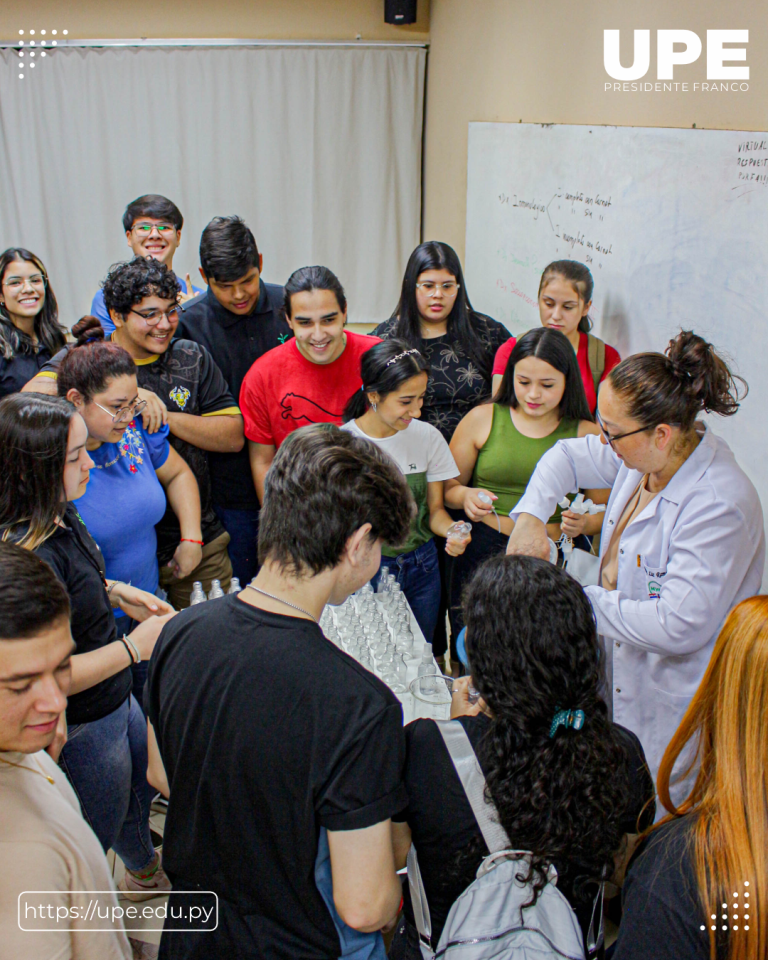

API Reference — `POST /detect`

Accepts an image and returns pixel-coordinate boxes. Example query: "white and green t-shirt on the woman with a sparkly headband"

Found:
[341,420,459,557]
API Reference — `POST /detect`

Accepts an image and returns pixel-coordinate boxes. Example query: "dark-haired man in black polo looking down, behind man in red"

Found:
[176,217,293,583]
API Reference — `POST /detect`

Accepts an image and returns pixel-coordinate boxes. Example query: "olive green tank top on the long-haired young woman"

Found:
[472,403,579,523]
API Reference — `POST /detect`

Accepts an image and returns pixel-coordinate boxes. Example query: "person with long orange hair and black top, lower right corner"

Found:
[613,594,768,960]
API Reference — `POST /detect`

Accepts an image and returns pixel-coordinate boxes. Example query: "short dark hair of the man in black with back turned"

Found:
[259,423,416,575]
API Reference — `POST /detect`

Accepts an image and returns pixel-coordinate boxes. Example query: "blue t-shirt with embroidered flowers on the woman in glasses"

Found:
[77,416,170,617]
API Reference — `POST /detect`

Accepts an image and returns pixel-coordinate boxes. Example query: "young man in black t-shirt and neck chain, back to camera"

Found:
[145,424,414,960]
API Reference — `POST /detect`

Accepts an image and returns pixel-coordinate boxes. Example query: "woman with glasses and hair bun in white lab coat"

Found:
[507,331,765,795]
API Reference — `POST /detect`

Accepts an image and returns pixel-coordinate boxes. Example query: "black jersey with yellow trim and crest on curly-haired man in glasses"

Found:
[45,340,240,567]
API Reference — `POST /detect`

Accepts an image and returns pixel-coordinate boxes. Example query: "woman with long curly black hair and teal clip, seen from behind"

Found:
[390,556,655,960]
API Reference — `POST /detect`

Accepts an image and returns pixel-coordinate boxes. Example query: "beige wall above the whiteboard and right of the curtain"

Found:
[424,0,768,257]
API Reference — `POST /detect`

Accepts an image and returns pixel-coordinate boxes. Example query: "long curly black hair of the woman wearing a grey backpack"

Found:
[464,556,630,903]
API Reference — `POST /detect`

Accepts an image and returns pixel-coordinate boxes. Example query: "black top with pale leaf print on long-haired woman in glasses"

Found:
[372,313,510,442]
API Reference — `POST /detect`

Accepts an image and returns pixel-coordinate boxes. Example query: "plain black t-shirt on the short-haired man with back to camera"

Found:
[144,596,406,960]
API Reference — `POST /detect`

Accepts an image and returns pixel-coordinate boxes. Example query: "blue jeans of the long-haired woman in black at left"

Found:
[59,695,155,870]
